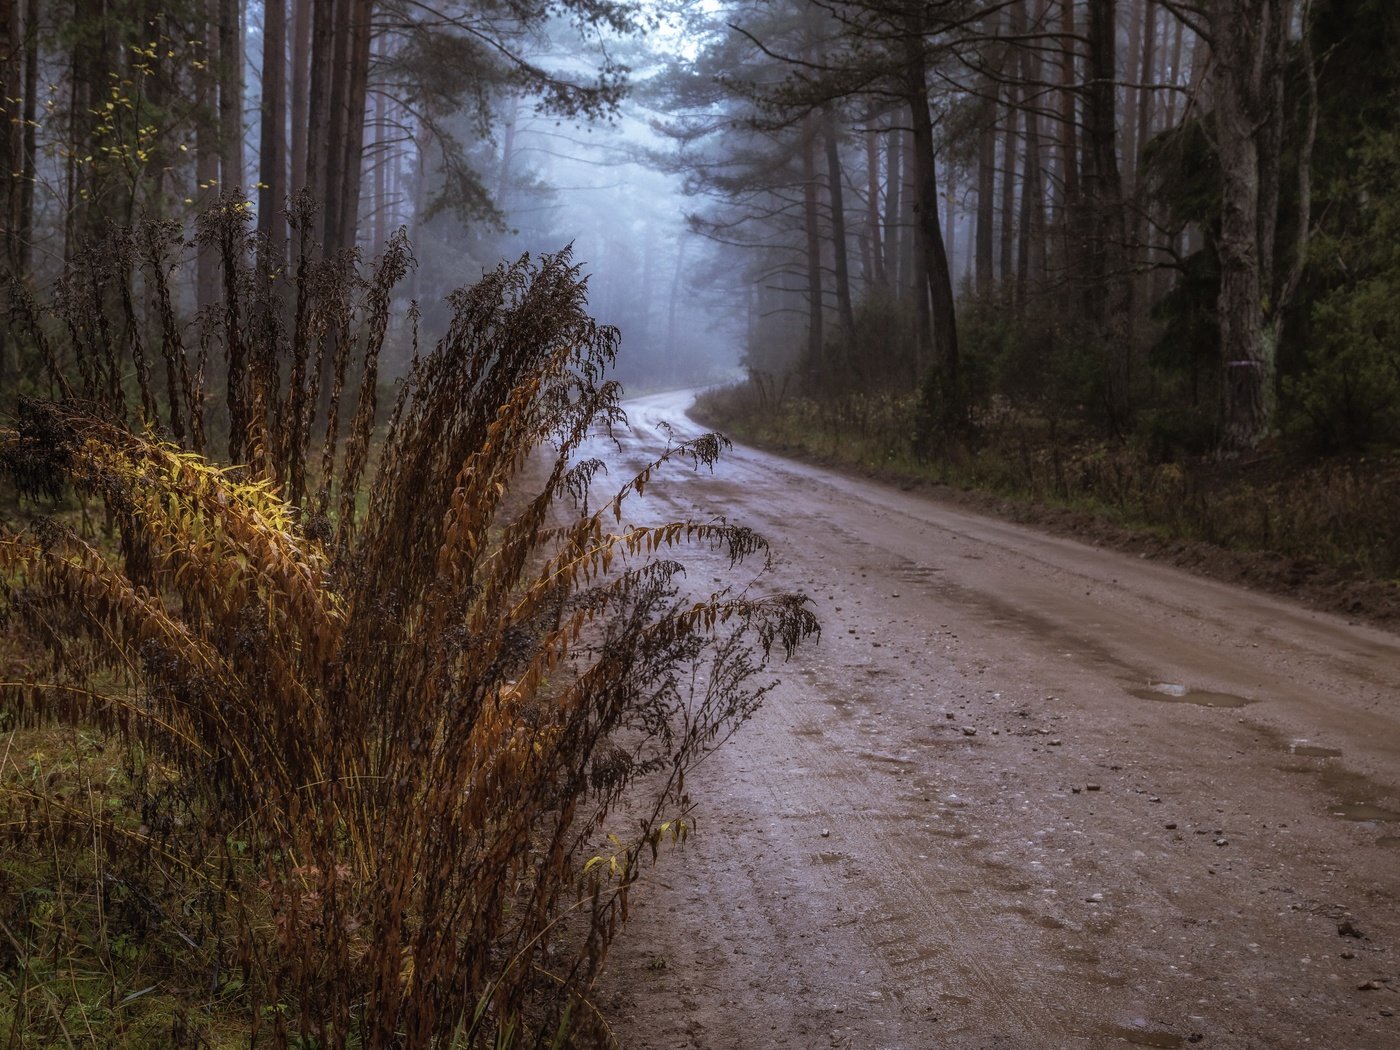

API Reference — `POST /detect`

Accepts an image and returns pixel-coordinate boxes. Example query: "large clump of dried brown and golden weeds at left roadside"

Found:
[0,202,818,1047]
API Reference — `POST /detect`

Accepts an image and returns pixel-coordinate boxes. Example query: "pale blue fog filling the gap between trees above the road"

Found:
[394,10,746,395]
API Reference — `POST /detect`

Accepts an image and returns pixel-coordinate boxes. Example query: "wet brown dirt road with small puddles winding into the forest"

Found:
[598,395,1400,1050]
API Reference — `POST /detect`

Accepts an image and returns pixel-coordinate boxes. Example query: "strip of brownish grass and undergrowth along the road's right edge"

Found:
[693,378,1400,622]
